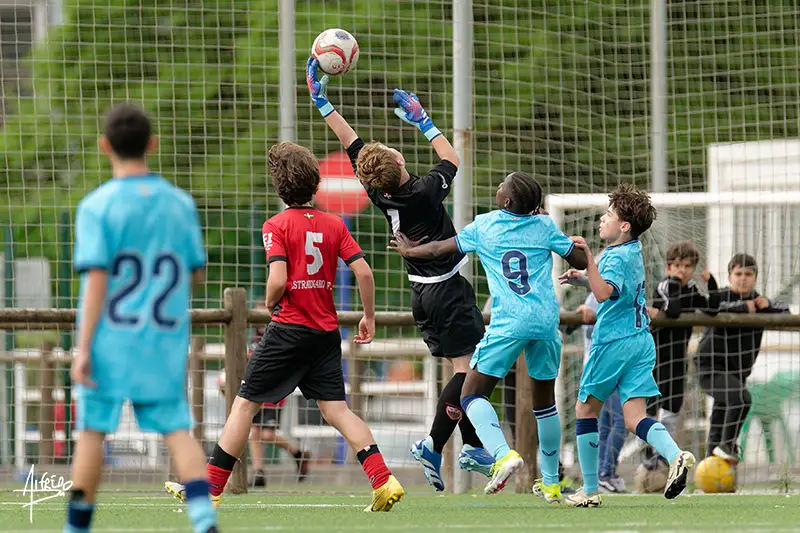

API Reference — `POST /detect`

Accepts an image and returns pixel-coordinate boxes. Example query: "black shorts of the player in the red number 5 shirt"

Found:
[239,322,345,403]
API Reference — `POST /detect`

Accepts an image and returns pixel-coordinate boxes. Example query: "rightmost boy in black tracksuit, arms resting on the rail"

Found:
[695,253,789,462]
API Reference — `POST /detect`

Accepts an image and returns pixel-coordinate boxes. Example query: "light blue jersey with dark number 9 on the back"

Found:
[456,209,574,340]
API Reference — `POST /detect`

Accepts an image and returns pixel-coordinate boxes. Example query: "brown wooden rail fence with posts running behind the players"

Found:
[0,288,800,493]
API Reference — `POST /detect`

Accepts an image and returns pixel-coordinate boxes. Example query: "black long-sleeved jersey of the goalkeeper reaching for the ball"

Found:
[347,139,467,283]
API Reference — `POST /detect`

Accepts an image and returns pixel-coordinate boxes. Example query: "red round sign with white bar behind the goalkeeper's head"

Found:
[314,151,369,217]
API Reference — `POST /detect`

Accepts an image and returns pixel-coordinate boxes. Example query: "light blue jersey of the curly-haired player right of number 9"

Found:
[592,239,650,344]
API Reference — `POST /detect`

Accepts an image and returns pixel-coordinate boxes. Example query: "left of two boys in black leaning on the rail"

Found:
[643,241,719,468]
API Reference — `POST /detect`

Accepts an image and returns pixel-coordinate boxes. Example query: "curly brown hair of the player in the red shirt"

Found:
[267,142,320,205]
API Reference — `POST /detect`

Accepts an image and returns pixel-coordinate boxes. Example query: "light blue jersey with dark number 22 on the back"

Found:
[74,175,206,402]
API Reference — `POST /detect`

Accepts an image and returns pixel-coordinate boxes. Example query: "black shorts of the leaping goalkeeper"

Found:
[411,274,485,358]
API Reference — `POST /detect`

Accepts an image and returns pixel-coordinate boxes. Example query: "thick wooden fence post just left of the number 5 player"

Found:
[224,288,247,494]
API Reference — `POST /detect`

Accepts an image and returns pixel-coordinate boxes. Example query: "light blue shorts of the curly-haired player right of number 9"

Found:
[578,331,661,403]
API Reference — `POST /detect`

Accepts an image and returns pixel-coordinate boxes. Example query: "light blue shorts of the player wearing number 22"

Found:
[76,390,192,435]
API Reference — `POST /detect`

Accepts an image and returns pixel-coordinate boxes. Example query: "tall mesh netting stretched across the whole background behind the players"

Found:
[0,0,800,492]
